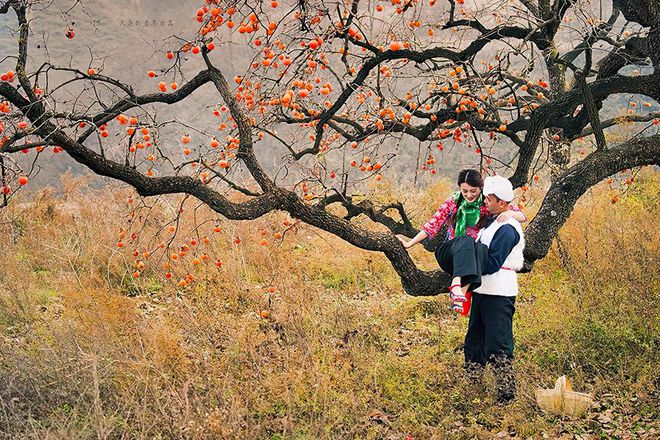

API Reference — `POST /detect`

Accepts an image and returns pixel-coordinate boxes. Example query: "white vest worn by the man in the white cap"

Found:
[475,218,525,296]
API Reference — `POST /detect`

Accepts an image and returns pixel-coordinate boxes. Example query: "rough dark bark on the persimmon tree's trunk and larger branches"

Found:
[0,0,660,296]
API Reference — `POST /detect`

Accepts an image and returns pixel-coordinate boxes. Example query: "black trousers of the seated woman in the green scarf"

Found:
[435,235,488,290]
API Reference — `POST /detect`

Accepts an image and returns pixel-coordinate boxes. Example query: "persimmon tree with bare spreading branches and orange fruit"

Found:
[0,0,660,295]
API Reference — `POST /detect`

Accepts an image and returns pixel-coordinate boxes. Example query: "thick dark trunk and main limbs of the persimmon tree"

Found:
[0,0,660,296]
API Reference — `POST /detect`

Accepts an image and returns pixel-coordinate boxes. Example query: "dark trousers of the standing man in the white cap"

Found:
[463,292,516,401]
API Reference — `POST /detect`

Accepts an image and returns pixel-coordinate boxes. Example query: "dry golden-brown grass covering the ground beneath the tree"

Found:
[0,172,659,439]
